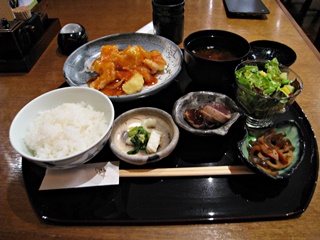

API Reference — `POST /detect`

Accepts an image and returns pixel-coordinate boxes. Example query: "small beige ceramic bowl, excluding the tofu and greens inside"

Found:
[109,107,179,165]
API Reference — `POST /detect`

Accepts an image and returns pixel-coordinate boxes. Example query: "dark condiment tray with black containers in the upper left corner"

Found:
[0,13,61,72]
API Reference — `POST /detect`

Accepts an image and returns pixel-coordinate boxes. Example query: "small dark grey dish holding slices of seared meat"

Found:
[172,91,240,136]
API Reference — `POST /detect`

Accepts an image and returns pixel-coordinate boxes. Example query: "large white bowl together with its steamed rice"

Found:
[9,87,114,169]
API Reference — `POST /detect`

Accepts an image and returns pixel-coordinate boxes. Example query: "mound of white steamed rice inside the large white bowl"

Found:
[25,102,107,159]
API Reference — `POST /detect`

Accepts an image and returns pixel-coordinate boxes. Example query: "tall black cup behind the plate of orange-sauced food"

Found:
[152,0,185,44]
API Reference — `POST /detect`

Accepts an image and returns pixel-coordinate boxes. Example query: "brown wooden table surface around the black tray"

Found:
[0,0,320,240]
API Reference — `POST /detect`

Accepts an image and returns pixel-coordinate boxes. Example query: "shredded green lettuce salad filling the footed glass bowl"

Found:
[235,58,301,119]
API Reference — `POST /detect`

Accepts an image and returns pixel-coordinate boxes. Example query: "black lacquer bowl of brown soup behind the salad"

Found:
[183,30,250,91]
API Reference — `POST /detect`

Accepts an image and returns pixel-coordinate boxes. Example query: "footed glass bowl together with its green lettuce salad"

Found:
[235,58,303,128]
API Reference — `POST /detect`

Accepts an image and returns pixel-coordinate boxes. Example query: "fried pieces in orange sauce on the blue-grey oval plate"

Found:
[88,45,167,96]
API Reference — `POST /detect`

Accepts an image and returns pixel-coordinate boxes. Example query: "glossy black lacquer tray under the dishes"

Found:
[22,64,319,225]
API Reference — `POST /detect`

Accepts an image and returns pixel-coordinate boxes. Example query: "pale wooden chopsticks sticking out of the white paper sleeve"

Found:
[119,165,253,177]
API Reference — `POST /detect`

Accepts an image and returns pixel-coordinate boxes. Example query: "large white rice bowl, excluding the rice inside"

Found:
[9,87,114,169]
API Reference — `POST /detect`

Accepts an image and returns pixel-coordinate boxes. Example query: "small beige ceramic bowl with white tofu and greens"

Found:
[109,107,179,165]
